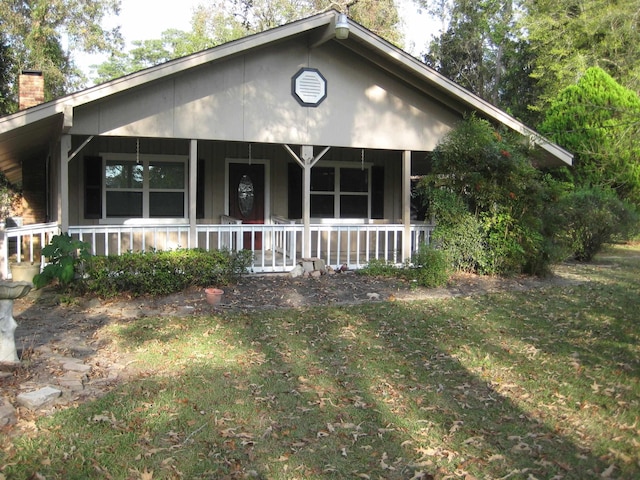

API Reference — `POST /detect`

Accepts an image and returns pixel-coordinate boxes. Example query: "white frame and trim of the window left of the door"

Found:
[99,153,189,225]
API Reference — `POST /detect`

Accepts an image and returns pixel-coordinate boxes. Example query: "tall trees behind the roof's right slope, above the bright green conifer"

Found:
[416,0,640,126]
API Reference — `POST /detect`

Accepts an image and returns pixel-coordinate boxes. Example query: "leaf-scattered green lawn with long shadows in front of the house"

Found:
[0,247,640,479]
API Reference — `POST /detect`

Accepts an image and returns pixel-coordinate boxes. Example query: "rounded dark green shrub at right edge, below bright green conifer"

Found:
[558,188,638,262]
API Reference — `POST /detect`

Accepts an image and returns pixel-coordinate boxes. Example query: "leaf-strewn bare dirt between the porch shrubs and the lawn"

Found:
[0,266,583,432]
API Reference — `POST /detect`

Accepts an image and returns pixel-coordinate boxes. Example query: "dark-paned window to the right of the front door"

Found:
[311,166,371,218]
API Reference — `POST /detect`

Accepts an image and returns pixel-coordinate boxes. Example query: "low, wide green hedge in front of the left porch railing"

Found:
[86,249,252,297]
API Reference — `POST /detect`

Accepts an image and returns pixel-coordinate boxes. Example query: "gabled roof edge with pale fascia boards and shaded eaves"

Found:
[0,10,573,184]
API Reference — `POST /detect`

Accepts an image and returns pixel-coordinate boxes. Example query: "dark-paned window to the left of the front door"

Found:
[104,155,187,218]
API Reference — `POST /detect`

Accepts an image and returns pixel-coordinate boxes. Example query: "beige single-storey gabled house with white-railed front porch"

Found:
[0,11,572,277]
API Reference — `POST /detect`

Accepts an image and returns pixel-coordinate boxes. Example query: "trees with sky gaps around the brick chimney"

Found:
[0,0,122,108]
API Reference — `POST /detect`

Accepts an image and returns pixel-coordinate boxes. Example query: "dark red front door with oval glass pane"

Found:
[229,163,264,250]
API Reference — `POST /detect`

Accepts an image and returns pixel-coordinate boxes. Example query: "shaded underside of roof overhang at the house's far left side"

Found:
[0,114,62,184]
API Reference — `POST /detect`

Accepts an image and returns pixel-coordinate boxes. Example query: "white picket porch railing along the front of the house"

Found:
[3,222,433,278]
